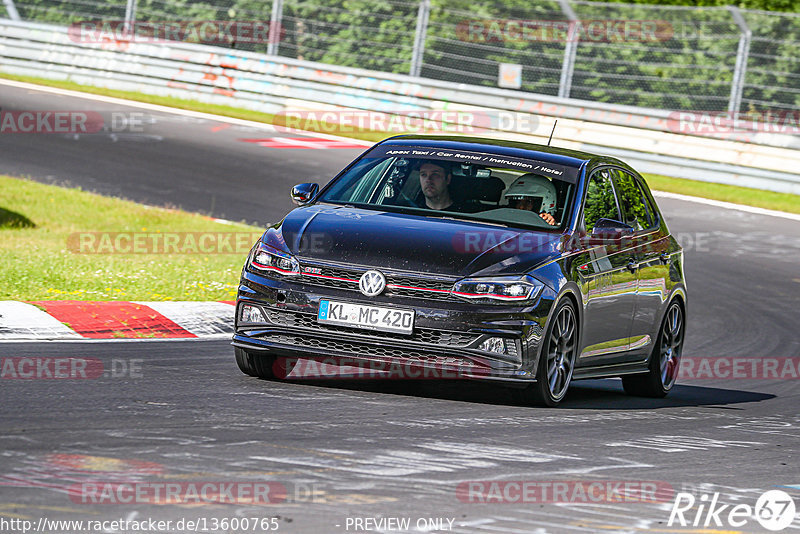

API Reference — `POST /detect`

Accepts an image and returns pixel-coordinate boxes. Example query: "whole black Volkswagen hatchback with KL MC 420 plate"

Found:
[233,135,687,406]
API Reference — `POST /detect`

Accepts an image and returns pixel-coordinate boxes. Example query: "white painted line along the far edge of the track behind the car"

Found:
[0,78,800,221]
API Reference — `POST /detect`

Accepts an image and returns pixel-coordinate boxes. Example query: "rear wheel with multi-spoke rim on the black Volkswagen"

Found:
[622,301,686,399]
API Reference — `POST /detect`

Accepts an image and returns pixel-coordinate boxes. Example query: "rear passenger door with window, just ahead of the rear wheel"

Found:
[614,169,669,361]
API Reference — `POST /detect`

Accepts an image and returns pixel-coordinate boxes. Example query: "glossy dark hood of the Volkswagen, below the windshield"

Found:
[264,205,561,277]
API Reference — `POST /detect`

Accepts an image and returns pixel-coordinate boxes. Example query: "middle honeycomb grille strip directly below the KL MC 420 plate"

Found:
[264,308,481,347]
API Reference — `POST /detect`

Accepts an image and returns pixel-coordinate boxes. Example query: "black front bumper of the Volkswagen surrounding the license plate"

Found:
[233,270,553,382]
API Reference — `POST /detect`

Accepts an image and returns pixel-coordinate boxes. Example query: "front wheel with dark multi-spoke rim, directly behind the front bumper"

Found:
[513,299,578,408]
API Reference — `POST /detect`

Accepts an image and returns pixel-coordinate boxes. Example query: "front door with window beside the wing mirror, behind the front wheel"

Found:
[577,168,636,367]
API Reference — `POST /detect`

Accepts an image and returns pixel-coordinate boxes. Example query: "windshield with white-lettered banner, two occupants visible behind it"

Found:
[320,146,578,230]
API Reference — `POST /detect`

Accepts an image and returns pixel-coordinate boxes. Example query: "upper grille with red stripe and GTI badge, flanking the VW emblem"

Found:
[300,263,455,300]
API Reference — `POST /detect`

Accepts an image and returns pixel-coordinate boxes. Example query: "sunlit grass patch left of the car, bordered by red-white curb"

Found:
[0,176,262,300]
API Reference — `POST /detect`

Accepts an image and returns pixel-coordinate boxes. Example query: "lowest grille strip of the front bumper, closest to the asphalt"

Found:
[268,334,489,369]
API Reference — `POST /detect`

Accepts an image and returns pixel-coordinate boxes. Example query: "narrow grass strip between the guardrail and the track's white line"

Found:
[0,73,800,217]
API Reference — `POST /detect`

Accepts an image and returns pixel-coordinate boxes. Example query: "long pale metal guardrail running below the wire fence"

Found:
[0,19,800,194]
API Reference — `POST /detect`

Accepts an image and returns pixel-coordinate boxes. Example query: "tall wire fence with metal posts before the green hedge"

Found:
[6,0,800,113]
